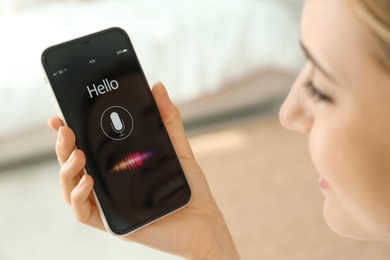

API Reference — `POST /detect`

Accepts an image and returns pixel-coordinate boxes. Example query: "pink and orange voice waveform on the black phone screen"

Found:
[110,151,154,173]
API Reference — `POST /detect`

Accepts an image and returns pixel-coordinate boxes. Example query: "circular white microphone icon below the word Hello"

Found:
[100,106,134,141]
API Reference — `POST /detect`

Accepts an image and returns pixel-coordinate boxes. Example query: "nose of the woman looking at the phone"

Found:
[279,75,314,133]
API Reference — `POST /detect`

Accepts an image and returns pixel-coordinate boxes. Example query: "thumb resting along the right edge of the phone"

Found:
[152,82,194,159]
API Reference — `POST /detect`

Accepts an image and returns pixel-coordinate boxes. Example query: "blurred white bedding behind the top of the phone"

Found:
[0,0,302,139]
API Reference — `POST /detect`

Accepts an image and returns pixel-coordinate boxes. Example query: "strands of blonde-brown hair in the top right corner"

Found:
[349,0,390,73]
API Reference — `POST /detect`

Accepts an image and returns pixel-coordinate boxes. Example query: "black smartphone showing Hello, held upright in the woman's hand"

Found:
[41,28,191,236]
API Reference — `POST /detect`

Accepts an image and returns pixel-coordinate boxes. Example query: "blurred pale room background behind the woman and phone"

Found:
[0,0,390,260]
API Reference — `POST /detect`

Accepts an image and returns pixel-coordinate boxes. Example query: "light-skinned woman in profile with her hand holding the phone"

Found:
[49,0,390,259]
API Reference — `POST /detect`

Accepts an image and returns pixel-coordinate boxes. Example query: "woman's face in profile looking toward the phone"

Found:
[280,0,390,240]
